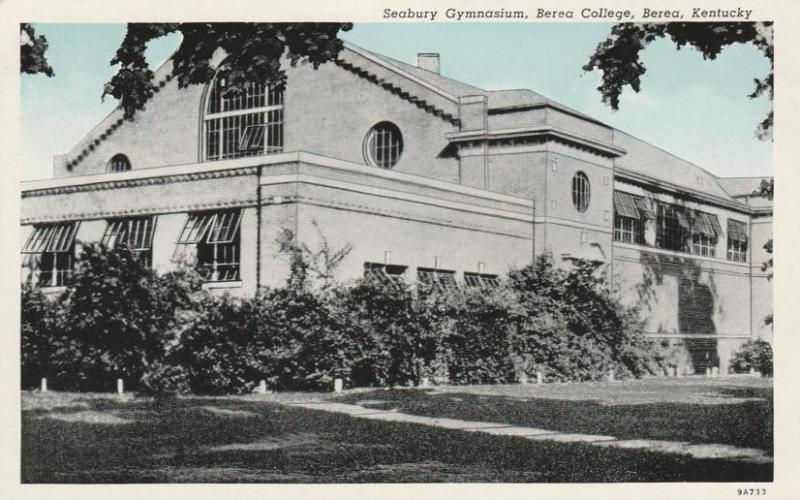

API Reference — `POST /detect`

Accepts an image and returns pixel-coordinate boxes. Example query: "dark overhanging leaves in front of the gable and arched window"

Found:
[101,23,352,120]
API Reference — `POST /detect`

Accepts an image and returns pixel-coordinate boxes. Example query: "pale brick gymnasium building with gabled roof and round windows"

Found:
[21,45,772,372]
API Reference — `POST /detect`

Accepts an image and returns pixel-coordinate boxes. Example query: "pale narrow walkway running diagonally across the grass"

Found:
[289,401,772,463]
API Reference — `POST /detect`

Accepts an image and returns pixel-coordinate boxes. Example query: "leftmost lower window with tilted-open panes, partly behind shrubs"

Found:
[22,222,80,287]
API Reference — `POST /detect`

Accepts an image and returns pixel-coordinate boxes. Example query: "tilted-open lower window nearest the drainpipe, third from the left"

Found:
[178,209,242,281]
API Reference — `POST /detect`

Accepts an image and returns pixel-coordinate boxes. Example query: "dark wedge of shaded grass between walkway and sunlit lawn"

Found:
[340,387,773,454]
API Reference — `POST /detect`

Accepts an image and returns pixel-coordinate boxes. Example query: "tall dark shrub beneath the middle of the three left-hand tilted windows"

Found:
[53,245,200,390]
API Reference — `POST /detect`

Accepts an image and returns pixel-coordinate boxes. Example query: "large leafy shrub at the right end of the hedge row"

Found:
[509,256,660,380]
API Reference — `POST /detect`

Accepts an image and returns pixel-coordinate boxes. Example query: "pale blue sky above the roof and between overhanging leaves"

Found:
[21,23,773,179]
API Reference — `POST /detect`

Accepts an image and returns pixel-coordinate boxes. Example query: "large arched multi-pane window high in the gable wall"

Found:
[203,77,283,160]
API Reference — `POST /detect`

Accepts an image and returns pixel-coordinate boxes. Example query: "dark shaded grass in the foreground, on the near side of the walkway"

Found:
[22,393,772,483]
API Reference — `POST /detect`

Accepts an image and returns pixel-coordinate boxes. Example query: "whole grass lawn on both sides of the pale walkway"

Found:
[21,379,772,483]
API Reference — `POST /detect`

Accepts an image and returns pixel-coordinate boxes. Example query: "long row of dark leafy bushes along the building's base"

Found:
[22,245,663,393]
